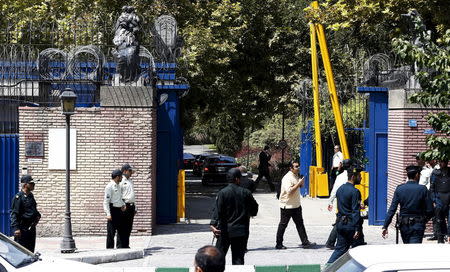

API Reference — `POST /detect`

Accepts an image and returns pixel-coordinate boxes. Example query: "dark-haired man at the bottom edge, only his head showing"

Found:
[194,246,225,272]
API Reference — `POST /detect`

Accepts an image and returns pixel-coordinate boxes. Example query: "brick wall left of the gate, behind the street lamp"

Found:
[19,107,156,236]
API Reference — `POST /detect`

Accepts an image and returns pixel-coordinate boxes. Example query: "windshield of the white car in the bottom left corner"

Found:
[0,235,38,268]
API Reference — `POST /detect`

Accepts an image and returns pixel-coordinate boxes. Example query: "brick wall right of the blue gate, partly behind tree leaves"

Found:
[388,108,450,207]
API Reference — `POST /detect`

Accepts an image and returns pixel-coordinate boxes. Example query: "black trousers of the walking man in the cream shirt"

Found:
[277,206,308,246]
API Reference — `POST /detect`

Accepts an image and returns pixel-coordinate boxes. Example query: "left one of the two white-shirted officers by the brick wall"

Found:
[103,169,127,248]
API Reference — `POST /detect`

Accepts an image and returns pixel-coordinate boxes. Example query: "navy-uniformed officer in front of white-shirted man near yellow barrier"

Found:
[327,166,363,265]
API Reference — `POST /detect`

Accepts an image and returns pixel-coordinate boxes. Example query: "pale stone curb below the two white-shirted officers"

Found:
[61,250,144,264]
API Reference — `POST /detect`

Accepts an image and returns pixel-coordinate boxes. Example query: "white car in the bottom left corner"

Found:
[0,233,104,272]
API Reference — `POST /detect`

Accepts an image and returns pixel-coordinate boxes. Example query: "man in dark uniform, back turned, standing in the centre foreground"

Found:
[210,168,258,264]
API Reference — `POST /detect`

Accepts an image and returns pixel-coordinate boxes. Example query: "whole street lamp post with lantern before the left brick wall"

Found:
[60,88,77,253]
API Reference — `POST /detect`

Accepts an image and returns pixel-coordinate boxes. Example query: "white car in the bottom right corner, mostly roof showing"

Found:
[324,244,450,272]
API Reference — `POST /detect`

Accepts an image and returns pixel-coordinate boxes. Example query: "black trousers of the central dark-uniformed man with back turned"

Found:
[216,233,248,265]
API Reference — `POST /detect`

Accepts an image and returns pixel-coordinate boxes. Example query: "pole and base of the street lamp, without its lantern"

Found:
[61,114,76,253]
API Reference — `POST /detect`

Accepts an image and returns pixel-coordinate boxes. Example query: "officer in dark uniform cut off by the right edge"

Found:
[430,160,450,243]
